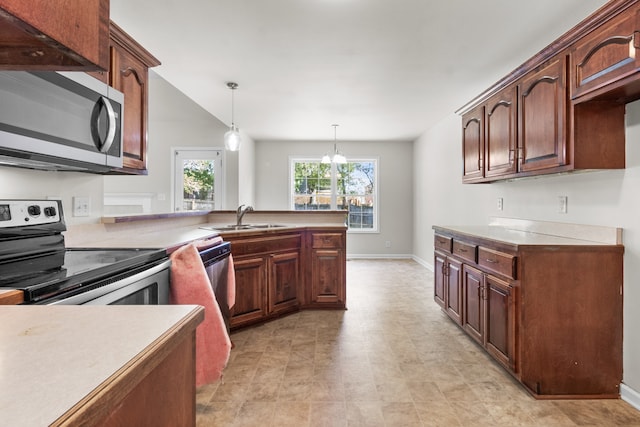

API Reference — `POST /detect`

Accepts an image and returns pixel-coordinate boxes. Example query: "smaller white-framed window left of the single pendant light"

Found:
[174,148,223,211]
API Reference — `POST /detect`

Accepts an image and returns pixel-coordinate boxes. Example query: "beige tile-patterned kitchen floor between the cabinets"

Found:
[197,260,640,427]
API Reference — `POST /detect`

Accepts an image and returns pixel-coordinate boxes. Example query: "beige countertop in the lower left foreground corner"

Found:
[0,305,201,427]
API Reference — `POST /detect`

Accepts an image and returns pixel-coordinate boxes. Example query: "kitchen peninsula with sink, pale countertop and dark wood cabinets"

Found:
[65,210,347,328]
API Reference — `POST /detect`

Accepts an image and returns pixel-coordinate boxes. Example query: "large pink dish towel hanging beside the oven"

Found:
[169,243,231,387]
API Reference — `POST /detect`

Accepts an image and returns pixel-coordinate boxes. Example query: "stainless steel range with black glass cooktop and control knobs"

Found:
[0,200,171,305]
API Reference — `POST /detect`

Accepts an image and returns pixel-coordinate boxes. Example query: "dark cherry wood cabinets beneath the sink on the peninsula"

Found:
[225,228,346,328]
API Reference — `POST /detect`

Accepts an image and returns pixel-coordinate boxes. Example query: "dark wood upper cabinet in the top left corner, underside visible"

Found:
[0,0,109,71]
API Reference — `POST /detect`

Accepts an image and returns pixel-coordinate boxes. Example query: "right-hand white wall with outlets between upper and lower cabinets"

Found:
[414,102,640,402]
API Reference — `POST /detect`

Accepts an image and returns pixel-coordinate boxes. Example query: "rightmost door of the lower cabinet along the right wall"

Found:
[485,275,515,370]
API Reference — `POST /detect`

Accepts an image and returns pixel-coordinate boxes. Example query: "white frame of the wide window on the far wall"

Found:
[289,156,380,234]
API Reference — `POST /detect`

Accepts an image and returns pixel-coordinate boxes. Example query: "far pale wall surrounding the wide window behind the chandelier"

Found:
[255,141,413,257]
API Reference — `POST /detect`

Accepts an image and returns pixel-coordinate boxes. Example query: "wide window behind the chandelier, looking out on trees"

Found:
[291,159,378,231]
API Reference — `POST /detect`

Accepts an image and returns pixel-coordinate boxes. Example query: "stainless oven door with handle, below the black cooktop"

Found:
[44,260,171,305]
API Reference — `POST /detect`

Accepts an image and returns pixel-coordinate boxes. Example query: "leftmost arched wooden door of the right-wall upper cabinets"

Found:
[462,107,484,182]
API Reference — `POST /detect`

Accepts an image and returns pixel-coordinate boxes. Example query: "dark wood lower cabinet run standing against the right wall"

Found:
[434,226,624,398]
